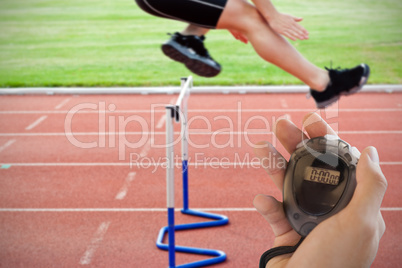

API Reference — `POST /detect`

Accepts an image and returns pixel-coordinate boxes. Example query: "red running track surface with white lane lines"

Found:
[0,93,402,267]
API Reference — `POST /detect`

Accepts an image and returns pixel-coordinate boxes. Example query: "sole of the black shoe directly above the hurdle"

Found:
[162,41,221,77]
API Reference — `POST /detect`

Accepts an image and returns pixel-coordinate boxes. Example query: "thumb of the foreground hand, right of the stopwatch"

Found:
[350,147,387,217]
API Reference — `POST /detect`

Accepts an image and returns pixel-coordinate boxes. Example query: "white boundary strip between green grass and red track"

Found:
[0,85,402,95]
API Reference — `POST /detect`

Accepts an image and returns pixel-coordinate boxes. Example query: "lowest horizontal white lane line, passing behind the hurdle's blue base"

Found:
[0,207,402,213]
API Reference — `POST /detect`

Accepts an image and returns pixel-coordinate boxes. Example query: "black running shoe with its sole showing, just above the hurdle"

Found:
[162,33,221,77]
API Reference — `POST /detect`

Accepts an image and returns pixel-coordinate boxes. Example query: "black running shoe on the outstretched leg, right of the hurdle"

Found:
[310,63,370,109]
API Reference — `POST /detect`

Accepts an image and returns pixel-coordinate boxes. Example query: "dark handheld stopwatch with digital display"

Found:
[283,135,360,237]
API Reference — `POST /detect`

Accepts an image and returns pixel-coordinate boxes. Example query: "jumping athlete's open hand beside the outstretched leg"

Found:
[268,12,309,41]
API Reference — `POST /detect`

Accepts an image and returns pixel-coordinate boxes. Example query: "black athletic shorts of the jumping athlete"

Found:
[135,0,228,29]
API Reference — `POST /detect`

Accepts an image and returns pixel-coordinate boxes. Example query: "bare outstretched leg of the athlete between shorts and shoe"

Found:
[217,0,329,91]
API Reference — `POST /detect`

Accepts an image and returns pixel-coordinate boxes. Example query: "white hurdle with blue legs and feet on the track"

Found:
[156,76,229,268]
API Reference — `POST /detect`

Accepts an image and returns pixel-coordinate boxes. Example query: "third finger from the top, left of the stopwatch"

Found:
[254,141,287,191]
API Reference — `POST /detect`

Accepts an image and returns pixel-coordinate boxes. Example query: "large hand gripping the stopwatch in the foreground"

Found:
[253,113,387,267]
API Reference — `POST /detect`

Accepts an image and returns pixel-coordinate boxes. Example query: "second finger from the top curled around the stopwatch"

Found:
[274,119,308,154]
